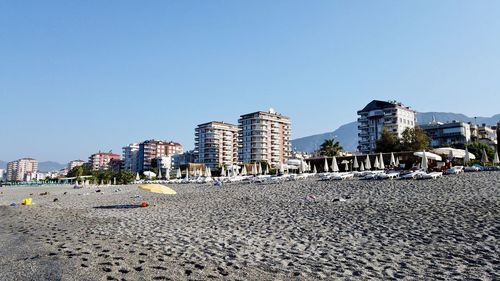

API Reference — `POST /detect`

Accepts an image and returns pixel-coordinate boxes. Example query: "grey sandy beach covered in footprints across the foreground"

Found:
[0,172,500,280]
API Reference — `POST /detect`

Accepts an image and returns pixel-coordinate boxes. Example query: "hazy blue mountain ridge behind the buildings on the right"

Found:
[292,112,500,153]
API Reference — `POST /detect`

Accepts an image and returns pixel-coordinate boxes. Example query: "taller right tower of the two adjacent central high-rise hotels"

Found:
[238,109,291,166]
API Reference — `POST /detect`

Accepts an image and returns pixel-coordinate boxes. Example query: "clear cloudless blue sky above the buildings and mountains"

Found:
[0,0,500,162]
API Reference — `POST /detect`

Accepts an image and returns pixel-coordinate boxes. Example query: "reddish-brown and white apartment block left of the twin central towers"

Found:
[137,140,183,172]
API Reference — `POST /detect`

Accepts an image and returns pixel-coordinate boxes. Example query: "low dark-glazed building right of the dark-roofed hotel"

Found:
[420,121,471,147]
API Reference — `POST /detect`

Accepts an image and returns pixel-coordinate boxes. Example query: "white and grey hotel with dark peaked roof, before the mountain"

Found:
[358,100,417,154]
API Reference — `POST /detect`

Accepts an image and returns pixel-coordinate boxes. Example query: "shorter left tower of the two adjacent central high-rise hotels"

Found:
[194,121,238,169]
